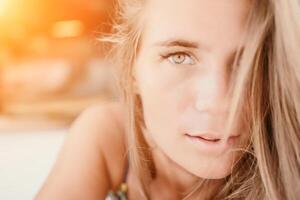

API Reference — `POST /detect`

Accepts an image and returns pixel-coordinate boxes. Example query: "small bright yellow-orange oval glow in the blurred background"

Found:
[52,20,84,38]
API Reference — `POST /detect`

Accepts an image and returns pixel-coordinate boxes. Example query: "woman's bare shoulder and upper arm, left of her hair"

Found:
[36,102,126,199]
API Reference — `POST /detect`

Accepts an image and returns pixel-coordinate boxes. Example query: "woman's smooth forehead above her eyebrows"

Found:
[143,0,250,52]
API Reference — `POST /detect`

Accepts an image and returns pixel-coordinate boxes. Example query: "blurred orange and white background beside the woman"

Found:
[0,0,117,200]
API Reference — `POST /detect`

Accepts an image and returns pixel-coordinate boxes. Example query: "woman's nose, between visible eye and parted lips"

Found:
[195,63,228,114]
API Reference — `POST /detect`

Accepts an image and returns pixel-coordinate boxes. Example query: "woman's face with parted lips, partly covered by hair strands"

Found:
[134,0,249,179]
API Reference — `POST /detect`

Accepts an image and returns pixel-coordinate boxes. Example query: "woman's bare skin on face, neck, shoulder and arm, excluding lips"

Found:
[36,0,253,200]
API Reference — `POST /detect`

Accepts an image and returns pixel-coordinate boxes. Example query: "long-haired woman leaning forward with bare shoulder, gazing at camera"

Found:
[37,0,300,200]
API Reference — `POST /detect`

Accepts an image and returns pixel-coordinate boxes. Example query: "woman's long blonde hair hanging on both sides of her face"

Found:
[102,0,300,200]
